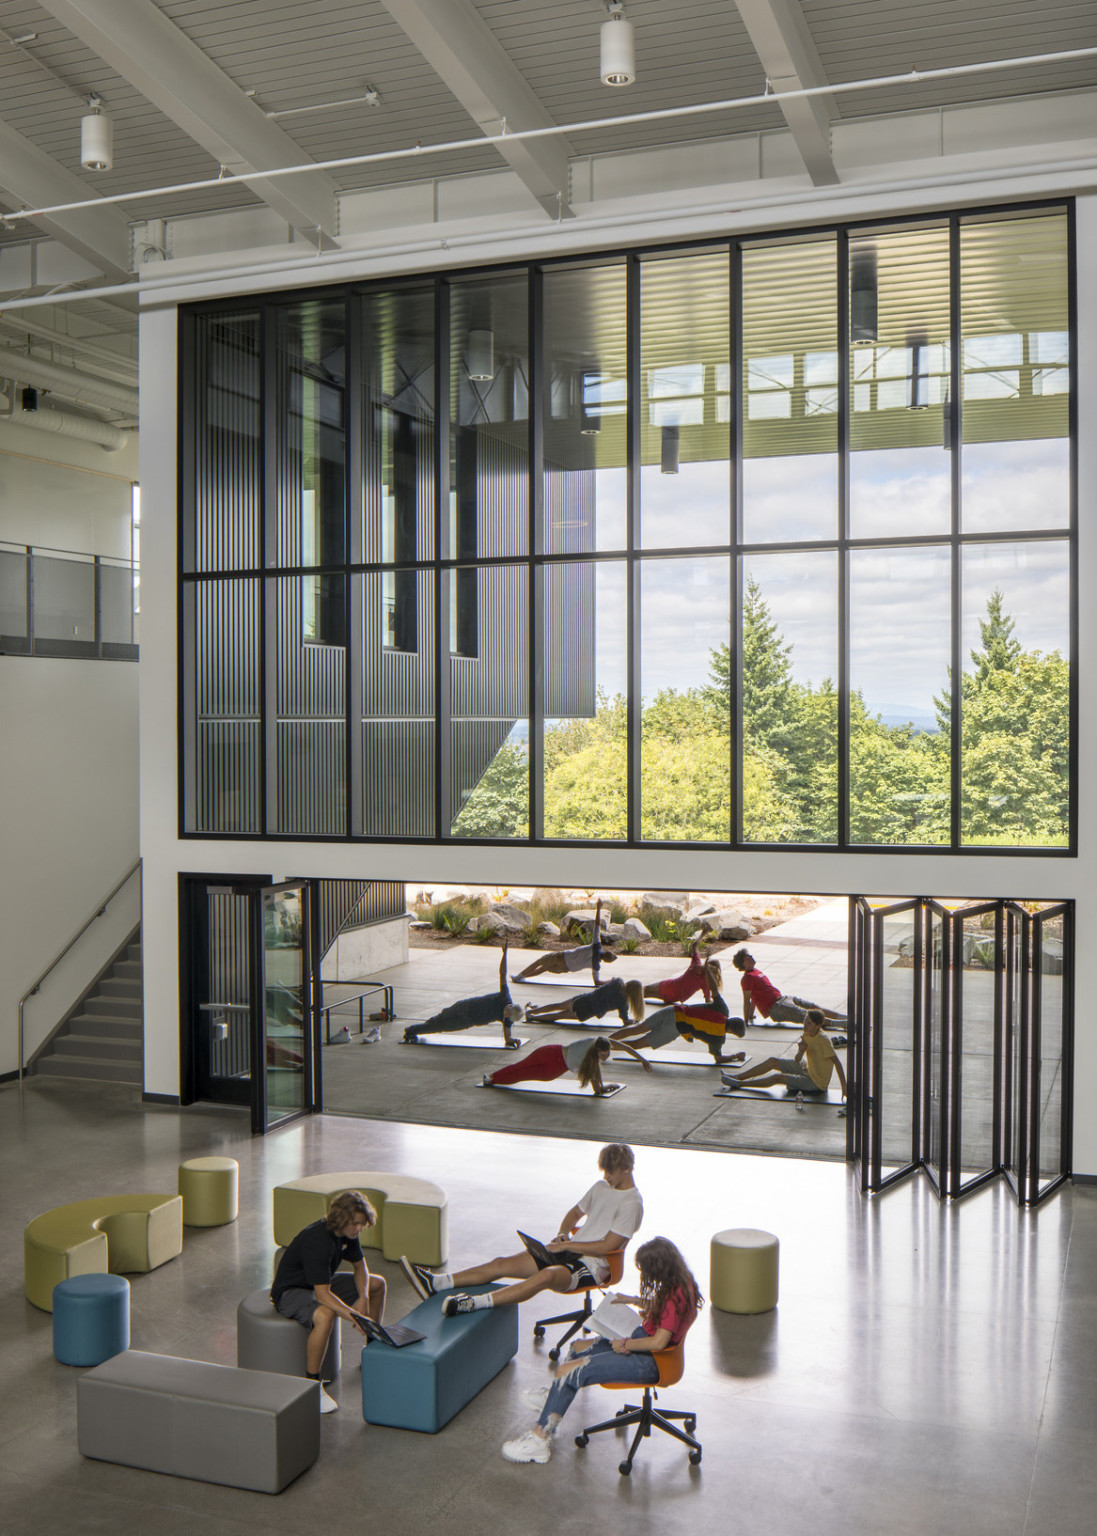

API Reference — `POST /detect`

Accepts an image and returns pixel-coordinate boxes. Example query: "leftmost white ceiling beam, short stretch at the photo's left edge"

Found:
[0,121,129,278]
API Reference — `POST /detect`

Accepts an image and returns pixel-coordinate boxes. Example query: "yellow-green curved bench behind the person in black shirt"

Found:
[273,1169,449,1264]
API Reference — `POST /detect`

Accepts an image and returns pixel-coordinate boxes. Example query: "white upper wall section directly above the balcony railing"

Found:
[0,421,137,559]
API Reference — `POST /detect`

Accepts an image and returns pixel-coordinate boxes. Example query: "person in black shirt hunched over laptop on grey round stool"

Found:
[270,1189,386,1413]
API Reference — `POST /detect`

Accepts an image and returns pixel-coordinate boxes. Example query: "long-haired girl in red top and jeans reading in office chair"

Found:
[502,1238,704,1462]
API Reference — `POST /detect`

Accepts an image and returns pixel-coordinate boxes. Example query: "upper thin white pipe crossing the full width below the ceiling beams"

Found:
[0,48,1097,227]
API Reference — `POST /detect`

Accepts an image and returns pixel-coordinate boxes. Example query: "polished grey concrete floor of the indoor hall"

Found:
[0,1083,1097,1536]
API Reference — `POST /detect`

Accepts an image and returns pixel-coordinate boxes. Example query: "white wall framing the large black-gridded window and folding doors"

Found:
[141,181,1097,1175]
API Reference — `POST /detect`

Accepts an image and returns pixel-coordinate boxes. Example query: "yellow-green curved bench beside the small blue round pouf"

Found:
[23,1195,183,1312]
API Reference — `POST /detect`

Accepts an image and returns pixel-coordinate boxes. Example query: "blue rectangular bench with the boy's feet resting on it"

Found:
[361,1286,518,1435]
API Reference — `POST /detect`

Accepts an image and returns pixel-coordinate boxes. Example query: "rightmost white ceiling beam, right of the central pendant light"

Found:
[734,0,840,187]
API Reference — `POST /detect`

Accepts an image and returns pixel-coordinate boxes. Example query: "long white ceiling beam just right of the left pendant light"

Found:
[43,0,338,247]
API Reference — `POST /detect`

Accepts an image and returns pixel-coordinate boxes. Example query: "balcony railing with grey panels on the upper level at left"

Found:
[0,542,140,662]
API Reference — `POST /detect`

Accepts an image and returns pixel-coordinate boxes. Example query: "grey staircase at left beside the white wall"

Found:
[34,932,144,1087]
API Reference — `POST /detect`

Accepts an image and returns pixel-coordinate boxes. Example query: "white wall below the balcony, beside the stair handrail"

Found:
[0,656,138,1074]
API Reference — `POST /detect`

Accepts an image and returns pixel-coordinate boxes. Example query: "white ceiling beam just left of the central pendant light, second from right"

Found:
[381,0,573,218]
